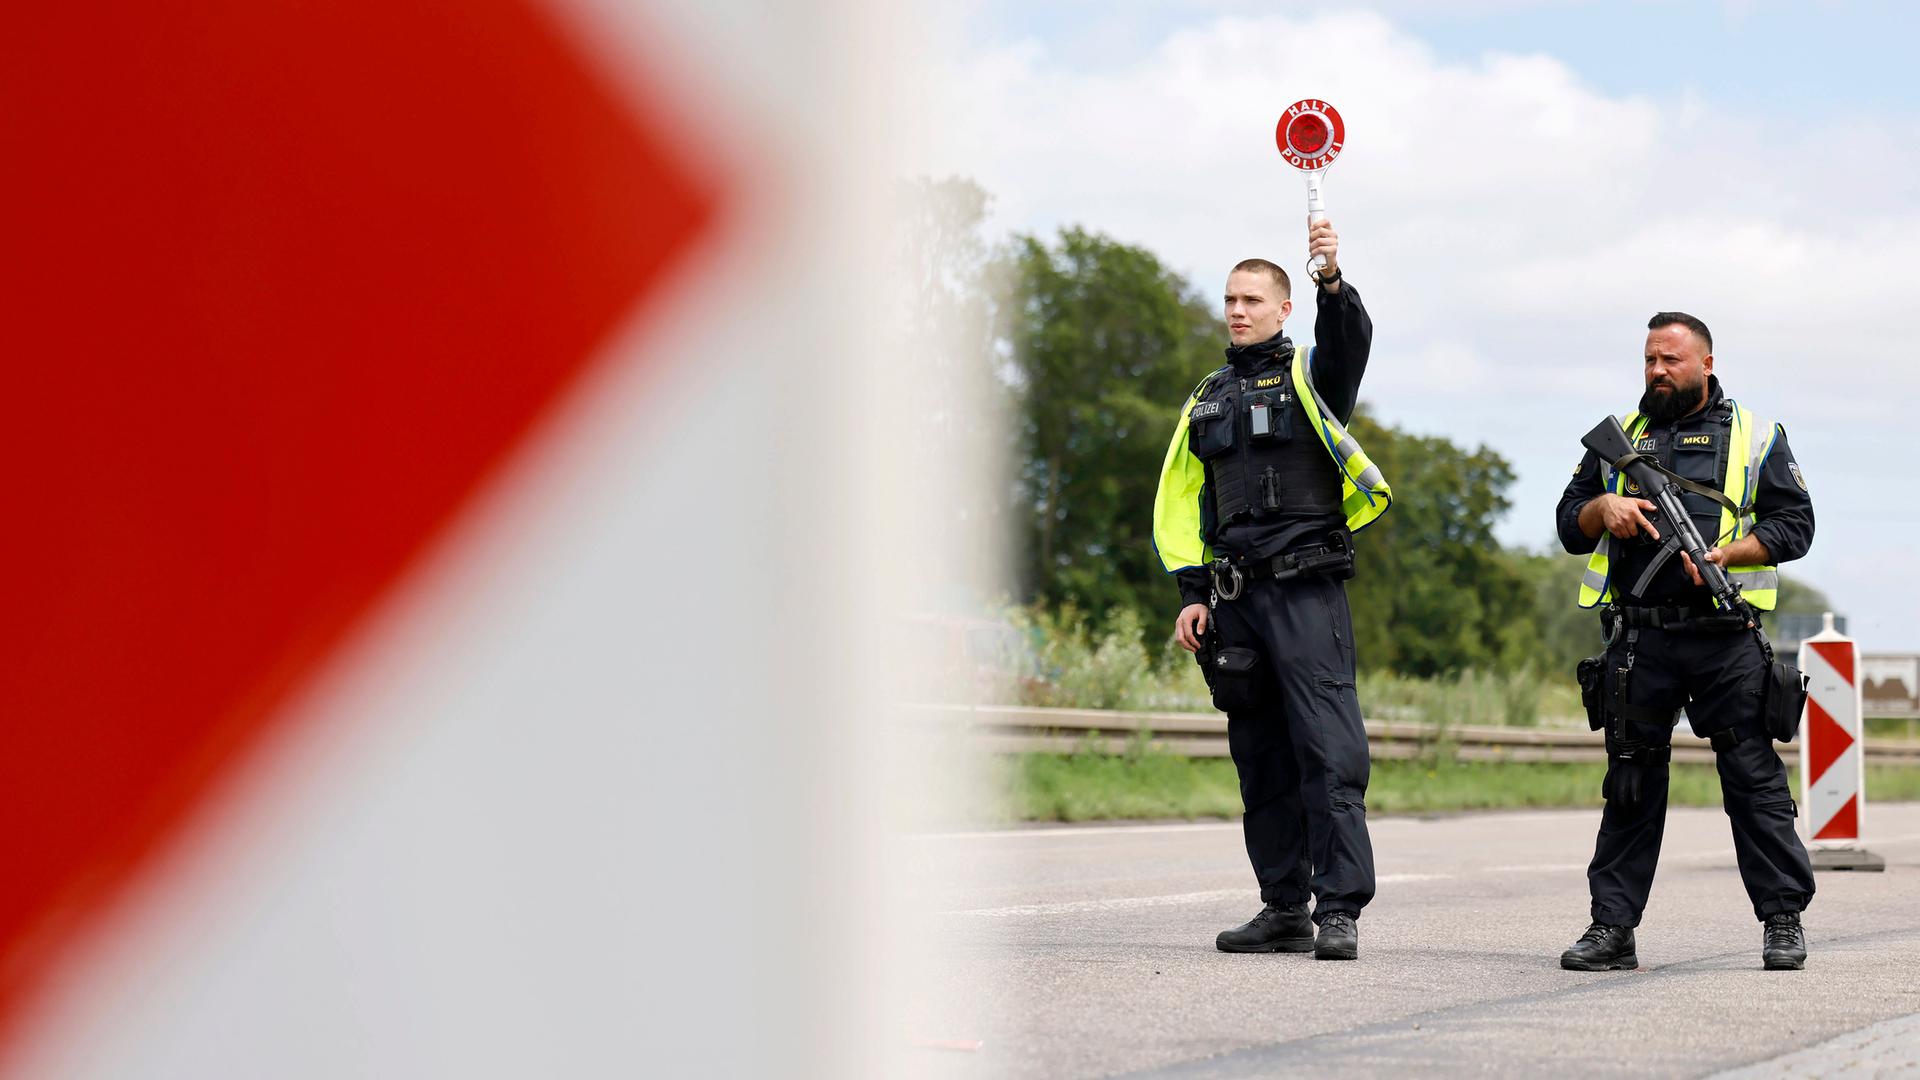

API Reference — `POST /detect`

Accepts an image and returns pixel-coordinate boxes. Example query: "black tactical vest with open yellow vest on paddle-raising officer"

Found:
[1154,346,1394,571]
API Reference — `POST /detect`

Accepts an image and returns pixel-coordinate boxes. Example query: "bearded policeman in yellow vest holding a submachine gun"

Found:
[1557,311,1812,970]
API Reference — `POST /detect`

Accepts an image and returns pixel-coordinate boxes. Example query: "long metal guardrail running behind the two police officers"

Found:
[904,705,1920,765]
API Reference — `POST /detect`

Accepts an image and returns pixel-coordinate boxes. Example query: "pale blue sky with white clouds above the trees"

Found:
[904,0,1920,651]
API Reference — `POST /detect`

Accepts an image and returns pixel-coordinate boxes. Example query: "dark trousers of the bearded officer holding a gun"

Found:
[1586,628,1812,926]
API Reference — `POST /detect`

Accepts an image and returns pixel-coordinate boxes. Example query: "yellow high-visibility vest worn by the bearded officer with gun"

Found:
[1580,400,1780,611]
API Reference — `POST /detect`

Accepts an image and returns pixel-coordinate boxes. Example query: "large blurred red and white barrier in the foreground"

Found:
[0,0,929,1076]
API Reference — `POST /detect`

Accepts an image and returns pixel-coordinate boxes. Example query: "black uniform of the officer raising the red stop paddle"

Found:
[1177,282,1373,922]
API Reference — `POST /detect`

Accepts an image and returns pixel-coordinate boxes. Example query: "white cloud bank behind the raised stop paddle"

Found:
[918,13,1920,648]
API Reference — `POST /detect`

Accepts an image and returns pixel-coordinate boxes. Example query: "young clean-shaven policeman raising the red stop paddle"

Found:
[1154,219,1390,959]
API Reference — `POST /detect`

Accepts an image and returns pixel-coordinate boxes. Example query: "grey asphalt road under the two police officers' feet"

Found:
[900,803,1920,1078]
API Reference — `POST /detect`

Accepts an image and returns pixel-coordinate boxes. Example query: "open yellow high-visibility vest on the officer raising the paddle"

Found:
[1154,346,1394,573]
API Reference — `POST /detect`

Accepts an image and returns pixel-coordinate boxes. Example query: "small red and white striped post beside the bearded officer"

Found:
[1799,611,1885,871]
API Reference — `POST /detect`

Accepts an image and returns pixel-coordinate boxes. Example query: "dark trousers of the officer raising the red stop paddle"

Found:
[1213,577,1373,920]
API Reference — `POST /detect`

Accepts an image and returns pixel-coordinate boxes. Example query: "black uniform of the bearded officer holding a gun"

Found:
[1557,377,1812,926]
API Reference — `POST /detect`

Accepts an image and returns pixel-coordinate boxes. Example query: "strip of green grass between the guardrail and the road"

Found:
[983,744,1920,822]
